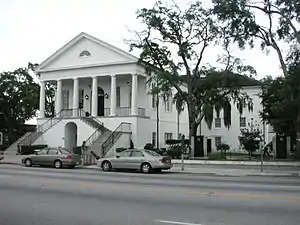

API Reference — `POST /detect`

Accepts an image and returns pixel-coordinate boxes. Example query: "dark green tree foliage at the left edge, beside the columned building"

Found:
[0,65,39,138]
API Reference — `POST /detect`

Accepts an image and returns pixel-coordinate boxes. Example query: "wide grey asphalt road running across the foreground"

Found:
[0,165,300,225]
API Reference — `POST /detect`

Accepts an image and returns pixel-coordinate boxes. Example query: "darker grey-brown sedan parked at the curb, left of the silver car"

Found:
[22,147,81,169]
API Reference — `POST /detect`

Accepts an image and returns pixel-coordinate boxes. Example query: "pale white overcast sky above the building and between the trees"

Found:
[0,0,290,78]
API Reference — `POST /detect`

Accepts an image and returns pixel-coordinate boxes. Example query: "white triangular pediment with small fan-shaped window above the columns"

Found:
[37,33,138,72]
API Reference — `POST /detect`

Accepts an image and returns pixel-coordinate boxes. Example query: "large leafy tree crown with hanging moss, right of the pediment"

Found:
[130,1,251,136]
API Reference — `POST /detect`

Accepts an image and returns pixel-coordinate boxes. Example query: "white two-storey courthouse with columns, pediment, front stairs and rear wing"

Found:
[4,33,268,155]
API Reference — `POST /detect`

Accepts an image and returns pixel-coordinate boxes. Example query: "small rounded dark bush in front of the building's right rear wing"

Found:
[238,126,262,156]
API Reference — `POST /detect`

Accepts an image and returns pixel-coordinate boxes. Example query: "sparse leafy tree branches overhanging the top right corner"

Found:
[212,0,300,76]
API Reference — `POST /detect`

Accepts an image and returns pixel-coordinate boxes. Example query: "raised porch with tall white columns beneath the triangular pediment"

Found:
[39,73,146,118]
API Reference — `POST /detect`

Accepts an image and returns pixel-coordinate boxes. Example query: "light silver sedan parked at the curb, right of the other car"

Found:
[97,149,172,173]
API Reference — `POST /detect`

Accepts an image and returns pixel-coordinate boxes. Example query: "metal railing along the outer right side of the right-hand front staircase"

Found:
[101,122,131,156]
